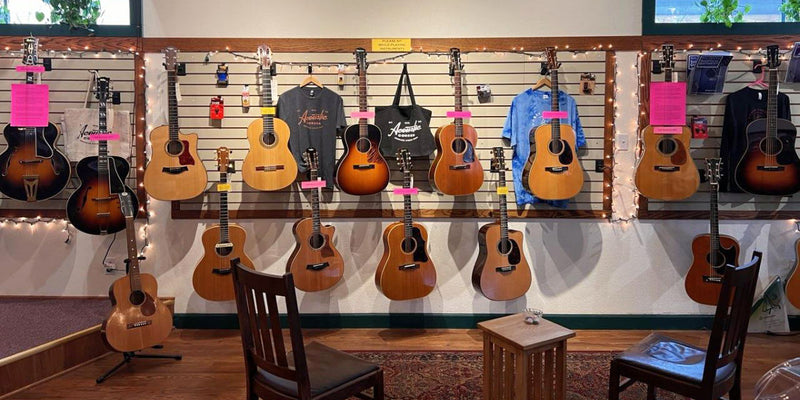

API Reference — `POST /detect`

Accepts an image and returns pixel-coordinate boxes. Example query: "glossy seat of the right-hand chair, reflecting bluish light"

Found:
[615,333,736,384]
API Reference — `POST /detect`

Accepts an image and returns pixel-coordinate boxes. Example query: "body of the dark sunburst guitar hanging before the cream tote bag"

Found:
[67,156,139,235]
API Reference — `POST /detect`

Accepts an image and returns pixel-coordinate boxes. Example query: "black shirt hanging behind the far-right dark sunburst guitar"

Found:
[719,87,791,192]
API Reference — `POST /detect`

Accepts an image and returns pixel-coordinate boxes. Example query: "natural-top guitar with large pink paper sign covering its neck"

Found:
[635,45,700,200]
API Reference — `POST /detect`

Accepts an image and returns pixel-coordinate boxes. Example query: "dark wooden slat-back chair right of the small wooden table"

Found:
[608,252,762,400]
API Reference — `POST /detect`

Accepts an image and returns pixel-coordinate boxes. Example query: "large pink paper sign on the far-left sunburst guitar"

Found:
[10,83,50,128]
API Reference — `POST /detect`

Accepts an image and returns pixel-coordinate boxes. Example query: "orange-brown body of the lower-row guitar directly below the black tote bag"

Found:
[375,222,436,300]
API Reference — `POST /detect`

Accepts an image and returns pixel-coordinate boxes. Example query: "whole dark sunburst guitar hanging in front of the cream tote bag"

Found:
[67,77,139,235]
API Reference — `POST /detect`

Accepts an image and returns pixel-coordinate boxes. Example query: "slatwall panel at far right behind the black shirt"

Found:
[640,52,800,218]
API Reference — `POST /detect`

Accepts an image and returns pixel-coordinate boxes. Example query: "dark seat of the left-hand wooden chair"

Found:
[256,342,379,396]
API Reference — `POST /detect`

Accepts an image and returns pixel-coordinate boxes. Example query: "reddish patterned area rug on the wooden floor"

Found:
[351,351,682,400]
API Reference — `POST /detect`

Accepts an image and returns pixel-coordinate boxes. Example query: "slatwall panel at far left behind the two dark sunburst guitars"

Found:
[0,52,138,217]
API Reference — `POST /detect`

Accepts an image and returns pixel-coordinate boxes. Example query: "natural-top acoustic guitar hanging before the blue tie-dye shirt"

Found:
[522,47,583,200]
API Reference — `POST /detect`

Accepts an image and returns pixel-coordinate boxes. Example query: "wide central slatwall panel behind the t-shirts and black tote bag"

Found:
[166,52,606,218]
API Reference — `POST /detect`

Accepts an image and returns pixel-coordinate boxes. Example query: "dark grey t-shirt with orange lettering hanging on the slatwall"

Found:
[277,86,347,188]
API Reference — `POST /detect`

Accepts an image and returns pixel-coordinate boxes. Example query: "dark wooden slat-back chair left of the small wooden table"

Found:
[231,258,383,400]
